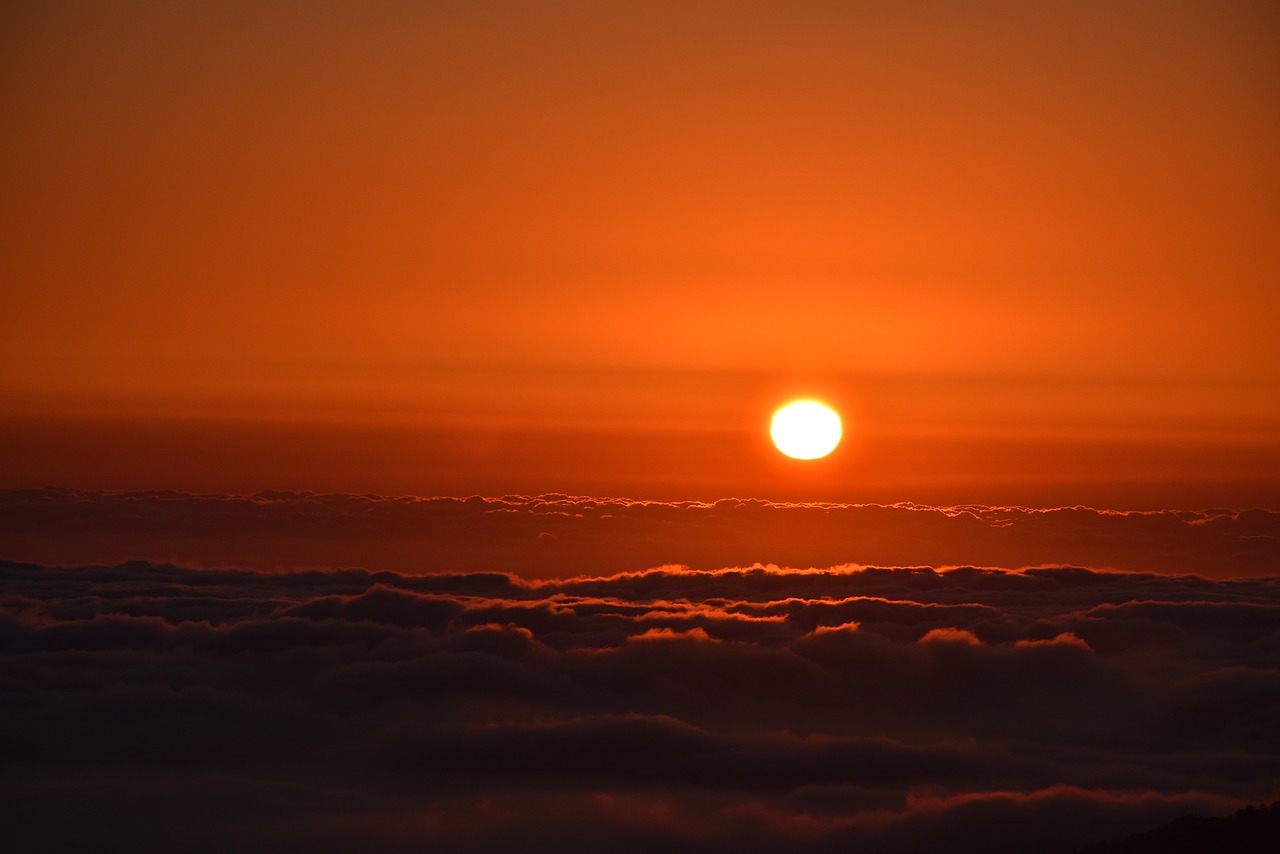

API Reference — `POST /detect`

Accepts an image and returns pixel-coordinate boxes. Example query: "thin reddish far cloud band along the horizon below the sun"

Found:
[0,489,1280,577]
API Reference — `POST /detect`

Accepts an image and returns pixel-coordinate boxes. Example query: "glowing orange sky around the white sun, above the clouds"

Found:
[0,3,1280,506]
